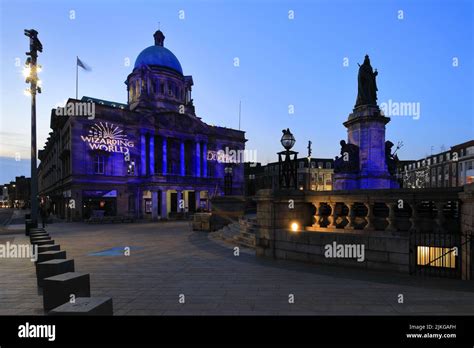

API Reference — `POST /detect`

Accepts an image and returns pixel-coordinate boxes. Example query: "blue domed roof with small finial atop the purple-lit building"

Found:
[134,31,183,75]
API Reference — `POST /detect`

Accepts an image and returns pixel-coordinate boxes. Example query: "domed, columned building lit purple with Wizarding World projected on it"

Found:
[38,31,246,220]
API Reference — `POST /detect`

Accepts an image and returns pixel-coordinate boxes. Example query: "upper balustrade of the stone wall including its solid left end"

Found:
[256,187,463,232]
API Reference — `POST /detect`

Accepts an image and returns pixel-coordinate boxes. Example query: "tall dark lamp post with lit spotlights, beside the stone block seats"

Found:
[24,29,43,225]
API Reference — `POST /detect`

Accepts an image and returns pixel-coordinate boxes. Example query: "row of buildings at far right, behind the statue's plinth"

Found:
[401,140,474,188]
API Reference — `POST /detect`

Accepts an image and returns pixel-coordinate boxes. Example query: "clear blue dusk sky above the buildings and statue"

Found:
[0,0,474,181]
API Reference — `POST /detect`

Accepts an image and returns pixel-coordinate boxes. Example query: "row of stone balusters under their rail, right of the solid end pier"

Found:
[305,188,462,232]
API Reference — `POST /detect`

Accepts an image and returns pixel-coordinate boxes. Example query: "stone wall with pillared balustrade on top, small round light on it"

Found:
[255,185,474,279]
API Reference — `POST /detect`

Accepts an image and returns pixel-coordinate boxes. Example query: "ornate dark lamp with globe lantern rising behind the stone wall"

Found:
[278,128,298,189]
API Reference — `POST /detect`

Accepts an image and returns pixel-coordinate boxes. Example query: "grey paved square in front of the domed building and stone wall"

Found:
[0,222,474,315]
